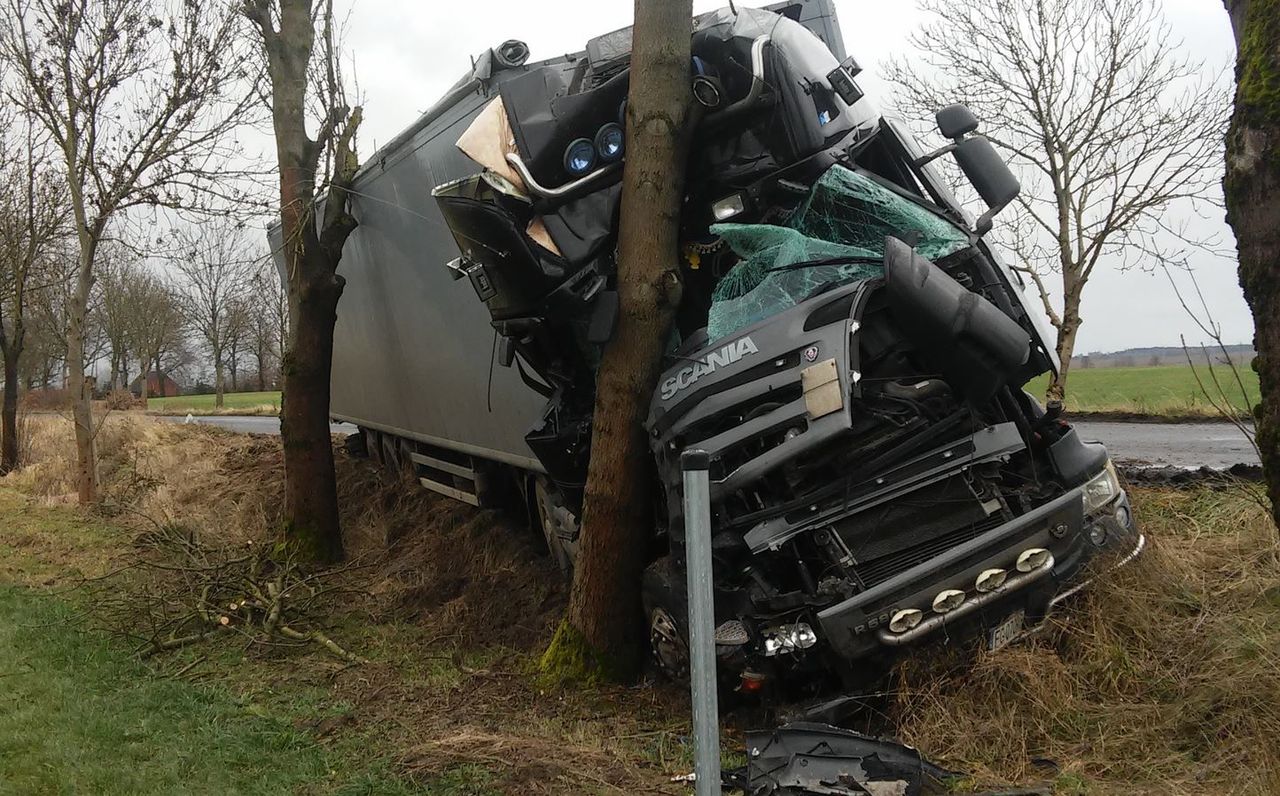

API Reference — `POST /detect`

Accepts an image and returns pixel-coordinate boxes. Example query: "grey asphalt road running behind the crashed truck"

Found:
[166,416,1258,468]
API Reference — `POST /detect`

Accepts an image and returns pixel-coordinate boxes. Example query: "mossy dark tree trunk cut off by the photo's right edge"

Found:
[1222,0,1280,525]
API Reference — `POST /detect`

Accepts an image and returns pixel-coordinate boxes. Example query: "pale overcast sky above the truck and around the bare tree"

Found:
[325,0,1253,353]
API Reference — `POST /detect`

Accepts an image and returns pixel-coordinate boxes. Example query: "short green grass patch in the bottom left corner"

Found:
[0,585,417,796]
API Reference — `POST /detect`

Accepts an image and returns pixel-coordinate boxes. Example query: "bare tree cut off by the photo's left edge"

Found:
[0,119,69,475]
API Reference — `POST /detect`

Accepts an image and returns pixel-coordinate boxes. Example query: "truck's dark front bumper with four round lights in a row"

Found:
[818,488,1144,659]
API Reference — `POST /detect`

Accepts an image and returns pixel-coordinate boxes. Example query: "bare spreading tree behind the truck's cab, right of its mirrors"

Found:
[887,0,1226,398]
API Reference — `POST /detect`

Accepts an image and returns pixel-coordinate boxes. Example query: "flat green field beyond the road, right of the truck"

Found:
[1027,365,1258,417]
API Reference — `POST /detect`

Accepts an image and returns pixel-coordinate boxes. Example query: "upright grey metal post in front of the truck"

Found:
[680,450,721,796]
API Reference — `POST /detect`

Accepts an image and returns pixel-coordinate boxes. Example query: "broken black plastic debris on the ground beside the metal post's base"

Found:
[723,722,954,796]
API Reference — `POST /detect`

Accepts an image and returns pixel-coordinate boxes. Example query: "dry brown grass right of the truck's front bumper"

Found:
[896,489,1280,793]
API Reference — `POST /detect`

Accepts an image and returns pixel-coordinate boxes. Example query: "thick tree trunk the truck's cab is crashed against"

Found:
[543,0,692,682]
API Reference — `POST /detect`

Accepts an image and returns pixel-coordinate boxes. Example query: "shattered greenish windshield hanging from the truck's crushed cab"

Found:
[707,165,969,342]
